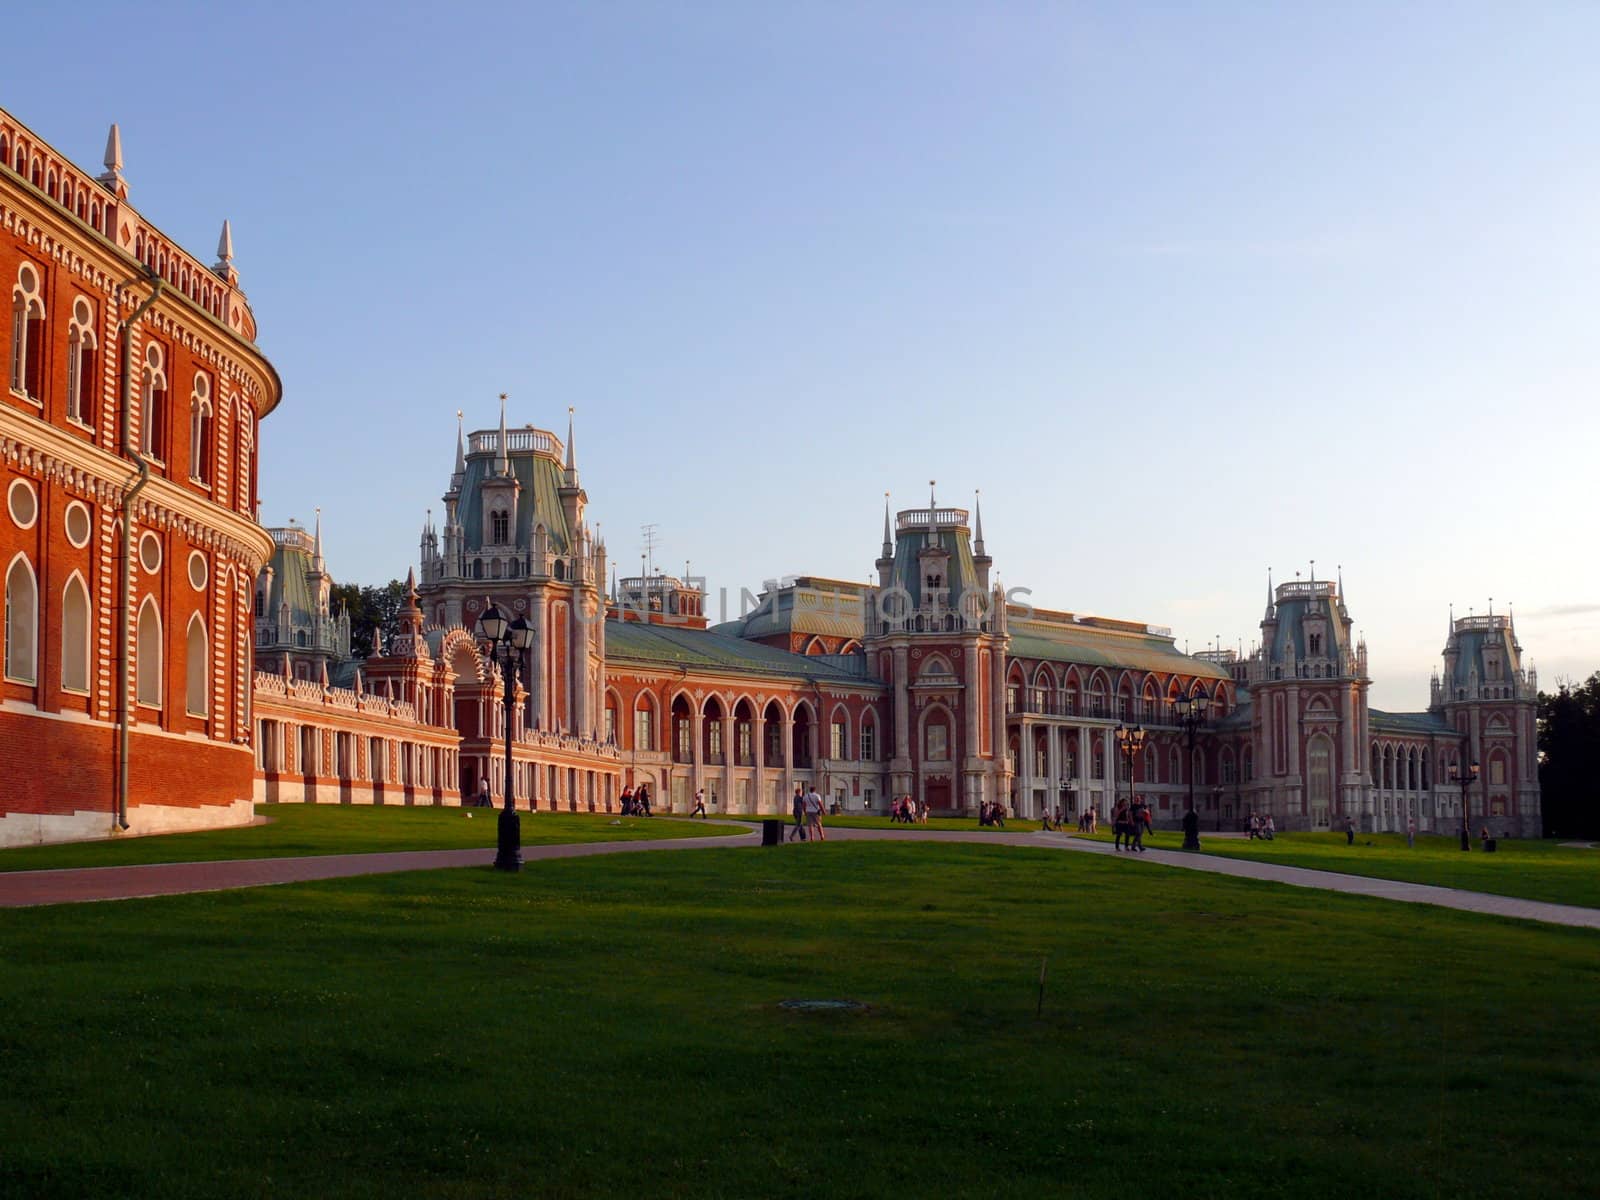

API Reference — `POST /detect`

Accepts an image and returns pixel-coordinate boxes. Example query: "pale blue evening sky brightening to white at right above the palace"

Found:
[0,0,1600,709]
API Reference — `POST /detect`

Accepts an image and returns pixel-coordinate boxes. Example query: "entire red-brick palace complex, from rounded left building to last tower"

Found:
[0,110,1539,845]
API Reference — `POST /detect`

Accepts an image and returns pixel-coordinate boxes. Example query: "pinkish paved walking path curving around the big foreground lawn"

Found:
[0,821,1600,930]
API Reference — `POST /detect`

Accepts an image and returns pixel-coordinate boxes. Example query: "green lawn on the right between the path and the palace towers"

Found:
[1075,829,1600,907]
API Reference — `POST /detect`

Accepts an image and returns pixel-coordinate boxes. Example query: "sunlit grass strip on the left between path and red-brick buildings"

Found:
[0,805,738,870]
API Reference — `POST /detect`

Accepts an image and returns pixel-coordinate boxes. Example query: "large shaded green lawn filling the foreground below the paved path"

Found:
[0,844,1600,1200]
